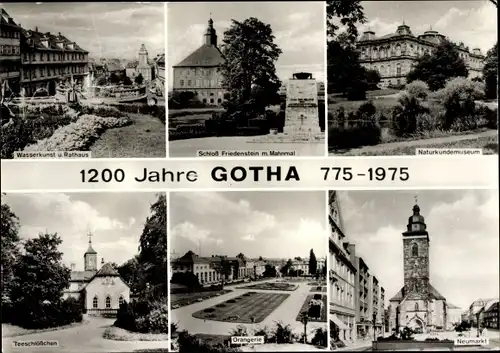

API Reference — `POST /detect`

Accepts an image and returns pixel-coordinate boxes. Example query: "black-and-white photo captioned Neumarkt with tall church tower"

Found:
[327,190,500,351]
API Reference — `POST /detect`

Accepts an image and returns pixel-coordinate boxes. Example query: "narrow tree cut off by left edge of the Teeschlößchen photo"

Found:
[0,200,21,298]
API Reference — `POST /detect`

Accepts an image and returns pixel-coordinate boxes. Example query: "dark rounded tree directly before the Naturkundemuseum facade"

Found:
[406,39,469,91]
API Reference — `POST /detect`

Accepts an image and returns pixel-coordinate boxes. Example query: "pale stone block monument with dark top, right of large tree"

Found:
[251,72,324,143]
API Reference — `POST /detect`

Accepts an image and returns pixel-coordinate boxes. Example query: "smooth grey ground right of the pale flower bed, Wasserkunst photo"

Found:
[90,113,166,158]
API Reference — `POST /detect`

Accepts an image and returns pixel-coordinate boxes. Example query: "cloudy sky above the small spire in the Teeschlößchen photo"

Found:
[2,192,164,271]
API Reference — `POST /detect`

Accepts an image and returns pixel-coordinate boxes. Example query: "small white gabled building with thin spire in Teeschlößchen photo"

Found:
[64,234,130,315]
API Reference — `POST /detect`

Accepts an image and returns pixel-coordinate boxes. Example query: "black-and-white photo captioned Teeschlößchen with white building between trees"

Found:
[1,192,169,353]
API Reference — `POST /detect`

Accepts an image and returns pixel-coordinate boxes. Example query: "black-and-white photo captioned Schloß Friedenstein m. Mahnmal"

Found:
[167,1,326,157]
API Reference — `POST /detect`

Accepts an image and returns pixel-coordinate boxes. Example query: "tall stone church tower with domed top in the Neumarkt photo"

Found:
[403,202,430,296]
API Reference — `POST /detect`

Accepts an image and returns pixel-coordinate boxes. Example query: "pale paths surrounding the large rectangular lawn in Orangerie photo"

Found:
[171,283,327,339]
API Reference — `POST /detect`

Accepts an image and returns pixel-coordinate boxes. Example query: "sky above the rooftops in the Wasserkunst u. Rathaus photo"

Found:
[1,2,165,60]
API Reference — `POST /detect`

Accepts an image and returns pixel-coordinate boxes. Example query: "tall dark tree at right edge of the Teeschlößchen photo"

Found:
[138,193,168,296]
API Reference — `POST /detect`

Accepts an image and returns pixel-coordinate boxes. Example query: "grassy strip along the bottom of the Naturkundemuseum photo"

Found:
[344,136,498,156]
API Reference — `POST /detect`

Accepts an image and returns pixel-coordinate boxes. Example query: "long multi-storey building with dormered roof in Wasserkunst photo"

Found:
[21,28,89,97]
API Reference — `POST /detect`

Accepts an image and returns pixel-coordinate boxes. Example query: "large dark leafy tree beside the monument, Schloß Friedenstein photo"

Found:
[219,17,282,112]
